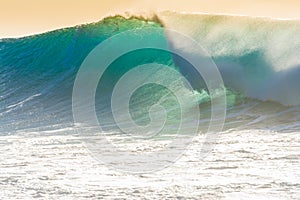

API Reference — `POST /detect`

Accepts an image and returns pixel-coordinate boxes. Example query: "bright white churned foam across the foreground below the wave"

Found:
[0,130,300,199]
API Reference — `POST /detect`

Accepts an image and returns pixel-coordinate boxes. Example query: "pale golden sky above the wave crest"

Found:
[0,0,300,38]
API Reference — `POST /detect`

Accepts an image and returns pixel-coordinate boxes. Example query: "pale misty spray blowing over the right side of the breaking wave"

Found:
[158,12,300,105]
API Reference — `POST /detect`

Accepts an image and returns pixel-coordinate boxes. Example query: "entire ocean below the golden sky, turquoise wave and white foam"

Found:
[0,12,300,199]
